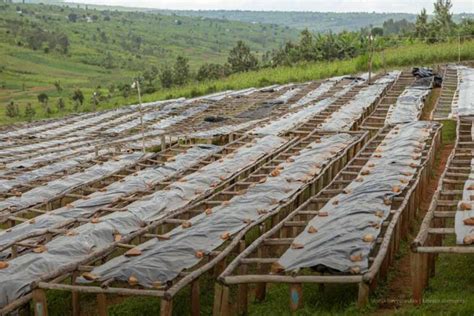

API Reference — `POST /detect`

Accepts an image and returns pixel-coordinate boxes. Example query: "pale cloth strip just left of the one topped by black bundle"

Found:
[319,71,401,131]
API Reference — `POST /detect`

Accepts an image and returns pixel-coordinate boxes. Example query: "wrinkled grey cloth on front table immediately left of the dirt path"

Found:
[275,122,438,273]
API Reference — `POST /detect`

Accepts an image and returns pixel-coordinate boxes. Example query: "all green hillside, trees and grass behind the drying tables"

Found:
[0,0,474,124]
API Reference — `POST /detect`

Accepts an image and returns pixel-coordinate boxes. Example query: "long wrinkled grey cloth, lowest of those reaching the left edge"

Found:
[0,136,288,307]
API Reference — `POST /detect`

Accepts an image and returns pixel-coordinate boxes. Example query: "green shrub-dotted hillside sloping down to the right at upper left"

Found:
[0,4,298,105]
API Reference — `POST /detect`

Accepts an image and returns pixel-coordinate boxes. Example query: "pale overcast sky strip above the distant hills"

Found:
[76,0,474,13]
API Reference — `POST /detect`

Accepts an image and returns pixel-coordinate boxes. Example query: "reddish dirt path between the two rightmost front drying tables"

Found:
[373,144,454,315]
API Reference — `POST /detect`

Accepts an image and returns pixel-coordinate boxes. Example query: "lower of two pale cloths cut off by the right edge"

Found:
[454,159,474,245]
